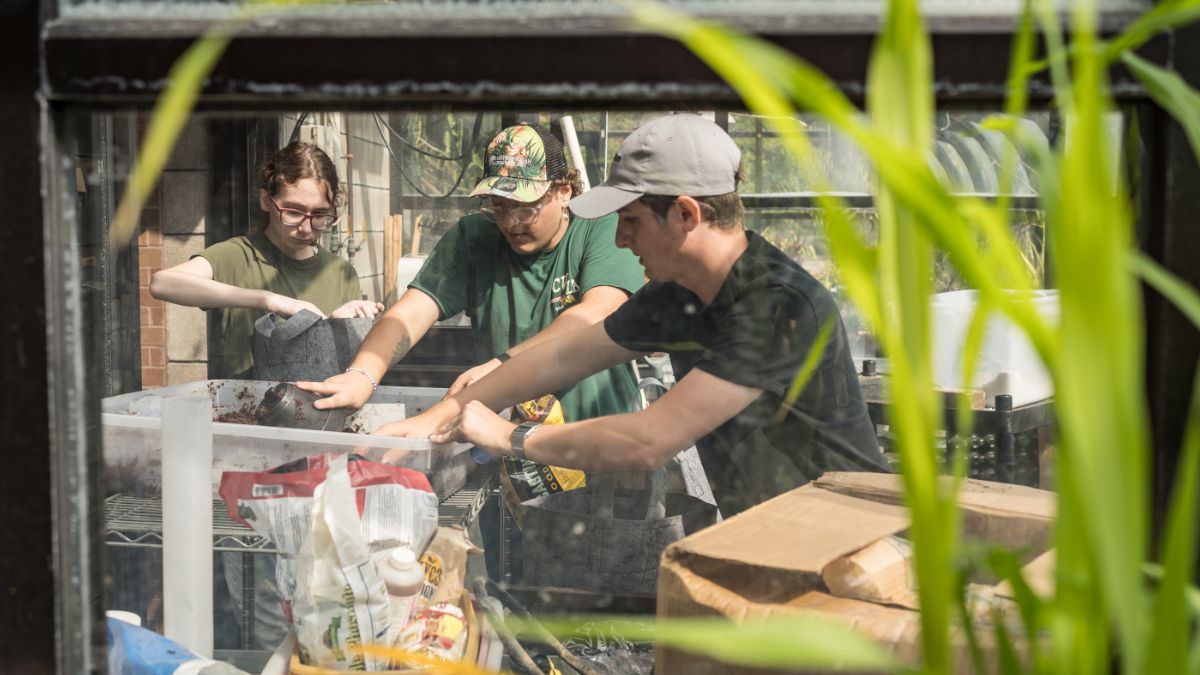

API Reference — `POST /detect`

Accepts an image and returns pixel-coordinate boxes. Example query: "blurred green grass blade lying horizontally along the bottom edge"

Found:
[506,615,901,671]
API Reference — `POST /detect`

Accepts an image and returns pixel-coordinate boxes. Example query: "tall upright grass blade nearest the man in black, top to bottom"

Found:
[866,0,959,673]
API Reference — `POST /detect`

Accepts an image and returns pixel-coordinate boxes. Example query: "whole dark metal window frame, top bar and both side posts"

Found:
[0,0,1200,673]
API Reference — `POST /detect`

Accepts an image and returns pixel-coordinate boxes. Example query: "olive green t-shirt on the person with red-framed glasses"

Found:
[199,232,362,380]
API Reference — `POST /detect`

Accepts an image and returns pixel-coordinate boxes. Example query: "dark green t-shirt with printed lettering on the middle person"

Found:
[409,214,644,422]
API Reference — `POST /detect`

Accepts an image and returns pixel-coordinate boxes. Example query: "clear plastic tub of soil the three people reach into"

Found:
[101,380,468,496]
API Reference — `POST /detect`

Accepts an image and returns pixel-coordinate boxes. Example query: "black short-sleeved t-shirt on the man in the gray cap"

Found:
[605,232,890,518]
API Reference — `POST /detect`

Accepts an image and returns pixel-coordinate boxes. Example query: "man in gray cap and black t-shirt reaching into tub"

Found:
[384,114,890,516]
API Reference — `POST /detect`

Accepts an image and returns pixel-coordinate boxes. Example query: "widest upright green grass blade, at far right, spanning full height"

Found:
[1039,2,1150,673]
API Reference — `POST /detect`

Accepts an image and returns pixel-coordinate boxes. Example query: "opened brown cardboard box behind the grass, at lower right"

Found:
[655,473,1055,675]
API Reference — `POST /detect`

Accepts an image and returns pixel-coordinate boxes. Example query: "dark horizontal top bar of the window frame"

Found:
[43,12,1165,109]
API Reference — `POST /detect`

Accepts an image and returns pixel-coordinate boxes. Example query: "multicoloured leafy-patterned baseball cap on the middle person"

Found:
[470,124,566,202]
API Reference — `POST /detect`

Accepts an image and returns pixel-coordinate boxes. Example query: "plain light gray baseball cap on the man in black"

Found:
[571,113,742,217]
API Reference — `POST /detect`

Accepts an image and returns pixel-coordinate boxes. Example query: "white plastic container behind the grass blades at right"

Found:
[930,289,1060,407]
